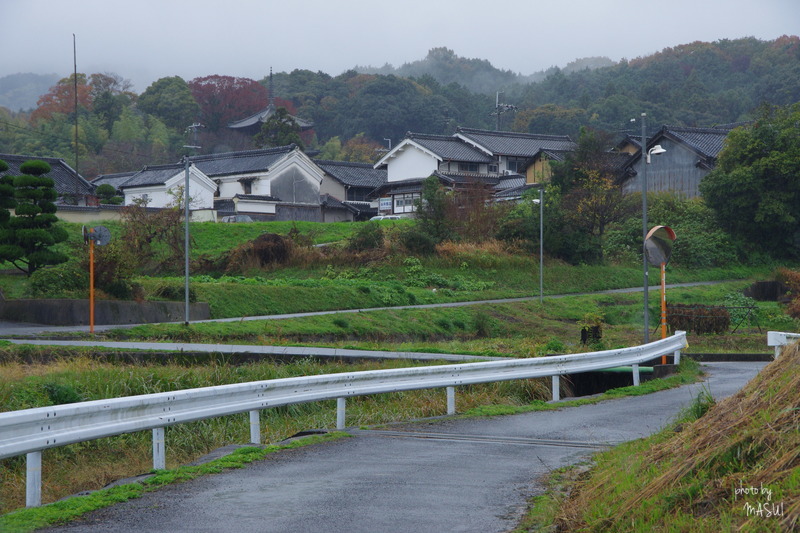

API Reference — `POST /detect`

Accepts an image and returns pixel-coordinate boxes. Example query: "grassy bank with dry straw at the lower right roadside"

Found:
[517,344,800,533]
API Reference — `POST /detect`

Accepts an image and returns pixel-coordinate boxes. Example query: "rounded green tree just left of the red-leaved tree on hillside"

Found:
[137,76,200,131]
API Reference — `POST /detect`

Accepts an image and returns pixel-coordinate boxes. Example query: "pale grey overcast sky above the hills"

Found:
[0,0,800,93]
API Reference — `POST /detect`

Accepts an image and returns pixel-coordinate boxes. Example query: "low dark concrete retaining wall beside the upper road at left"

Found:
[0,299,211,326]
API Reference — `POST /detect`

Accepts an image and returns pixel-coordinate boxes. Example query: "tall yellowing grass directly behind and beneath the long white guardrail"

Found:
[0,354,549,513]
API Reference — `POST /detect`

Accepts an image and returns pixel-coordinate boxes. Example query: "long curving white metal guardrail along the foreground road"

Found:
[0,331,686,507]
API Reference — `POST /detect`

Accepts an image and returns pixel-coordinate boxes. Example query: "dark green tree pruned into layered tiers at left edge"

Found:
[0,160,67,276]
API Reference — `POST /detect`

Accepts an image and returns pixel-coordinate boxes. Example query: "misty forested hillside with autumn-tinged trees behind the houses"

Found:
[0,36,800,178]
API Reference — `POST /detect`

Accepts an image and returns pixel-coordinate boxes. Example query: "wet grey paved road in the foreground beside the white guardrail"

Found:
[40,363,765,533]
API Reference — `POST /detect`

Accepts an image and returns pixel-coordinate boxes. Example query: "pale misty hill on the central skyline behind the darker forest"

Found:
[354,47,614,94]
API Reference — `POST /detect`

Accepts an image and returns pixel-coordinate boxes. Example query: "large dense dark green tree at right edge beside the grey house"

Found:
[700,104,800,257]
